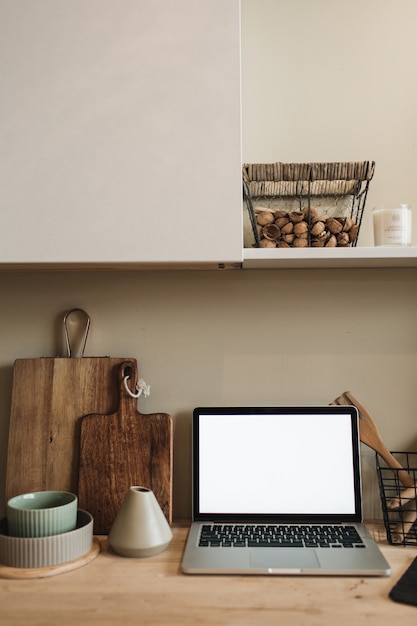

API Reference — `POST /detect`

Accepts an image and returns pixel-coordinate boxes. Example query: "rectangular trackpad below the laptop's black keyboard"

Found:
[250,548,320,569]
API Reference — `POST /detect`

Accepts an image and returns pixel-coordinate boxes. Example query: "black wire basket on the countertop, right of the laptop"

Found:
[376,452,417,546]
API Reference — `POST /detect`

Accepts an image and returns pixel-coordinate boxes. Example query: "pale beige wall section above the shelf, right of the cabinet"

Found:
[242,0,417,245]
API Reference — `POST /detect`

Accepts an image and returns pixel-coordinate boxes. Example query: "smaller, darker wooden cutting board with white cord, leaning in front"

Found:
[78,360,173,534]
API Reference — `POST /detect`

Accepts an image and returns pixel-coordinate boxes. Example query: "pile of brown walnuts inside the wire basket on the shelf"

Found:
[255,207,359,248]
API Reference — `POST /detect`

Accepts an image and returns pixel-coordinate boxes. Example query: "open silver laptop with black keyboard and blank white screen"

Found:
[182,406,391,576]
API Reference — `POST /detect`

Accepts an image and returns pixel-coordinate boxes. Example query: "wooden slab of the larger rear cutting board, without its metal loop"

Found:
[6,357,133,502]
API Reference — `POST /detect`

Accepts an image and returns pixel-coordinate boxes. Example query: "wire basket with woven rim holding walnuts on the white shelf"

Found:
[242,161,375,248]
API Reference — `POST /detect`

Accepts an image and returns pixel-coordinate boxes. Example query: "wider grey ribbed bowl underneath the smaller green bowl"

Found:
[0,509,93,568]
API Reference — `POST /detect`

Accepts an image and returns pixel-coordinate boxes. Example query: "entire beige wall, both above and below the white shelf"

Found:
[0,0,417,517]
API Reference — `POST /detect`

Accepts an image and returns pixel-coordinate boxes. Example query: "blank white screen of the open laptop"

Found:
[195,412,357,517]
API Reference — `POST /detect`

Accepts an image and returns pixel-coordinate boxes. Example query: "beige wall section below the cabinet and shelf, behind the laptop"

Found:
[0,270,417,517]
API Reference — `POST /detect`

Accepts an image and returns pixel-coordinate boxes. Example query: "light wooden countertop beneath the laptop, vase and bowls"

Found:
[0,524,417,626]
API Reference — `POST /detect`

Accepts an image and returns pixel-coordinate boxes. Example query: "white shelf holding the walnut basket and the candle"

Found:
[243,246,417,269]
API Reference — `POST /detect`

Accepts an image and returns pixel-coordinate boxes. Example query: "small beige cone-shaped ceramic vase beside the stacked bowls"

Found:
[109,487,172,557]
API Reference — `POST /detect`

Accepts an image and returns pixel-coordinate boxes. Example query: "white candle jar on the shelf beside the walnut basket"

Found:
[373,204,411,246]
